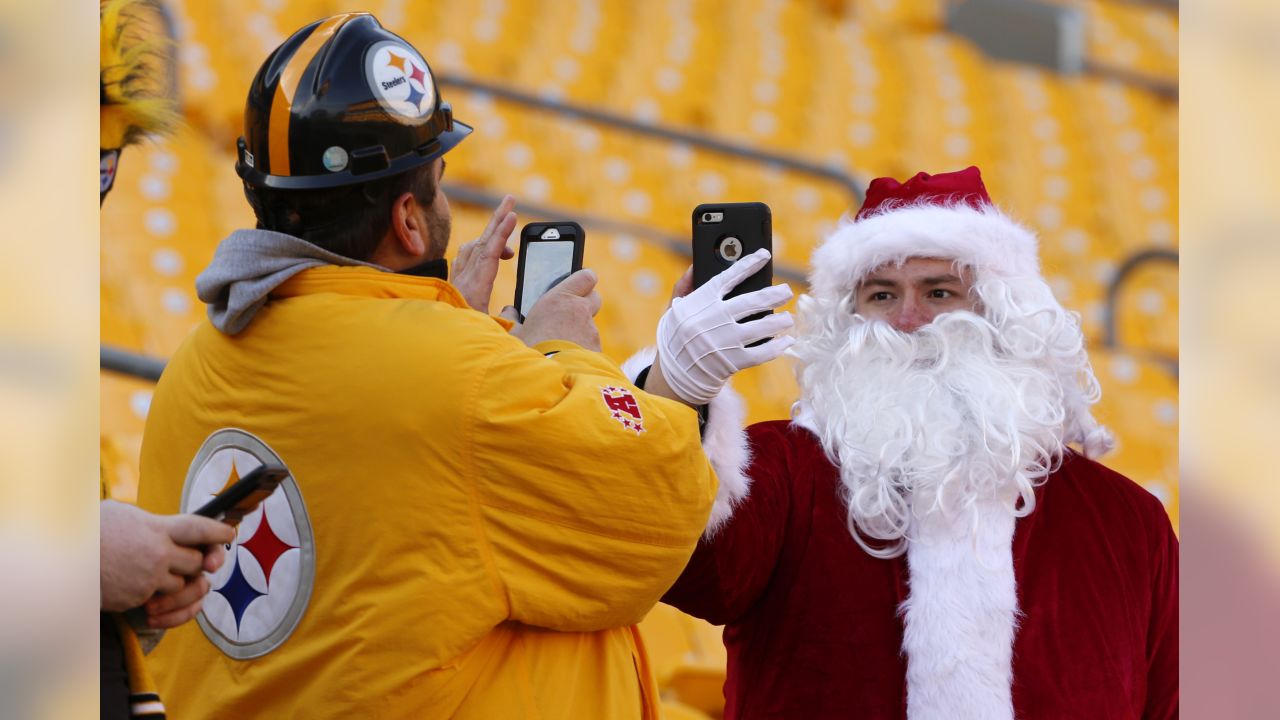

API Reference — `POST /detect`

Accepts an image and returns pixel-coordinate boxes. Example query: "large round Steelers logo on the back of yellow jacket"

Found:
[182,428,316,660]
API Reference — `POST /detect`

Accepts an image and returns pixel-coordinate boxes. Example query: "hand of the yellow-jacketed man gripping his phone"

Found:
[502,269,603,352]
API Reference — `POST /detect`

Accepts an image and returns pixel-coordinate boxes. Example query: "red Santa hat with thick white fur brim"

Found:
[809,167,1039,299]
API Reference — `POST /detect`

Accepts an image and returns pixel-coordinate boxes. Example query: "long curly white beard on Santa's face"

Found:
[792,299,1105,557]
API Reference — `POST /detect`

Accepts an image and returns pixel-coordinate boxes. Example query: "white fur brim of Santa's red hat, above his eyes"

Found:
[809,202,1039,299]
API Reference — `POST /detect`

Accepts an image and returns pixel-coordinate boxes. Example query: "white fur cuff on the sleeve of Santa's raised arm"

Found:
[622,347,751,538]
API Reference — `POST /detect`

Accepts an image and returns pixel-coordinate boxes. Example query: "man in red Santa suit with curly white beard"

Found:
[658,168,1178,720]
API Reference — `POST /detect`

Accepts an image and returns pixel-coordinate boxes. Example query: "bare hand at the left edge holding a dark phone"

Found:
[99,500,236,614]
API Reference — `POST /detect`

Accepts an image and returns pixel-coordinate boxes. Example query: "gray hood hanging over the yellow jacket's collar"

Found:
[196,229,389,334]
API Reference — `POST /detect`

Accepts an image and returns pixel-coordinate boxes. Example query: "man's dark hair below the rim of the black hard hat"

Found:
[244,163,438,260]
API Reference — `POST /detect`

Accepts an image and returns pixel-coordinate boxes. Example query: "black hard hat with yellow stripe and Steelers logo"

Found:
[236,13,471,190]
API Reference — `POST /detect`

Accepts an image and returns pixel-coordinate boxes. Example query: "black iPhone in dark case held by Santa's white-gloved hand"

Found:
[694,202,773,335]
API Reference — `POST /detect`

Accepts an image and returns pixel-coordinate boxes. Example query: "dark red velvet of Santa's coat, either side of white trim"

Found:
[664,421,1178,720]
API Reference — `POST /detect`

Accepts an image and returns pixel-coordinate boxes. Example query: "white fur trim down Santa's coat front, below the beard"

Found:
[901,501,1018,720]
